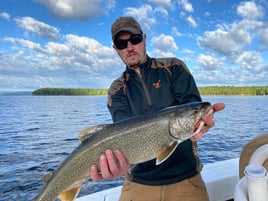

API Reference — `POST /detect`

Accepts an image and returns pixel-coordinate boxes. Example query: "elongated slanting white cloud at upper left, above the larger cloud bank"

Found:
[14,17,60,39]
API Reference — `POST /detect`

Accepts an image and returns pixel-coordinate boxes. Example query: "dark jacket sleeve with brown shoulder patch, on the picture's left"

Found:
[108,77,132,122]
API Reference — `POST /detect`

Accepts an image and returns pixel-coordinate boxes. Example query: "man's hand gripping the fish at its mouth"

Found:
[191,103,225,141]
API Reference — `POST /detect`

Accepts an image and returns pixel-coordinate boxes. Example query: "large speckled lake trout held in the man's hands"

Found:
[34,102,212,201]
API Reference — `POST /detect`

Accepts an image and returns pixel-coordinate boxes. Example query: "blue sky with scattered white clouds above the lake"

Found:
[0,0,268,91]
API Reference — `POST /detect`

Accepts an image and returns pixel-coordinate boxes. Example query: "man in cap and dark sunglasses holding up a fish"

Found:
[90,17,224,201]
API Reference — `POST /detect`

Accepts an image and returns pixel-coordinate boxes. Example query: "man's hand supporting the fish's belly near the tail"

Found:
[89,149,130,181]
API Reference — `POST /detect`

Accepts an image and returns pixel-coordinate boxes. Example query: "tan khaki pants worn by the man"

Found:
[119,174,209,201]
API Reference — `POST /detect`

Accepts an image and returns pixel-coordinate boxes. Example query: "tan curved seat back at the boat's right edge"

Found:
[239,133,268,178]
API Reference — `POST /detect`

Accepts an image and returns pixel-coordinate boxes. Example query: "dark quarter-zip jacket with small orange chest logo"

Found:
[108,56,201,185]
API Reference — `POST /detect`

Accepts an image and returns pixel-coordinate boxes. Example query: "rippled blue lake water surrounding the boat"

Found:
[0,96,268,201]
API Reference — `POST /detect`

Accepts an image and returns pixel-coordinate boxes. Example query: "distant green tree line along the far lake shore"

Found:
[32,86,268,96]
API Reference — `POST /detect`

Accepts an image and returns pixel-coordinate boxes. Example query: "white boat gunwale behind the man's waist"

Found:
[76,158,239,201]
